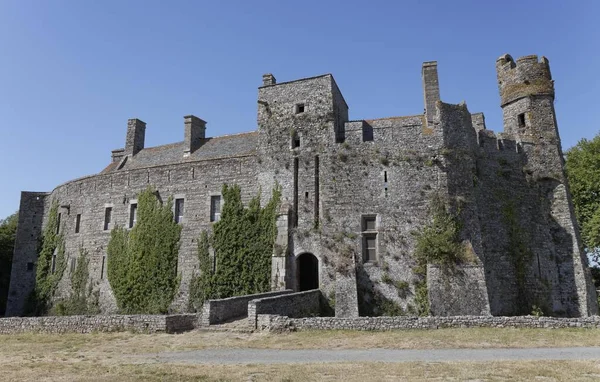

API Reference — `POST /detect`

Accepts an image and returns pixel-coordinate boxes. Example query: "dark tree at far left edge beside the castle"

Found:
[0,212,19,316]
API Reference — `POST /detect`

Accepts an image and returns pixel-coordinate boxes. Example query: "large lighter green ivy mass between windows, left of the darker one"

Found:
[107,188,181,314]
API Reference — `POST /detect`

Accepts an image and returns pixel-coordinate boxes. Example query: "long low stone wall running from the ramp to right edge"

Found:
[256,314,600,332]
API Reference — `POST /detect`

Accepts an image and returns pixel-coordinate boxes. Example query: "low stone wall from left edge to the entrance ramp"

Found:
[0,314,198,334]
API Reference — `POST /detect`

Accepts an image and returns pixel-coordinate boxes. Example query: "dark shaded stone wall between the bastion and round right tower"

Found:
[466,130,586,317]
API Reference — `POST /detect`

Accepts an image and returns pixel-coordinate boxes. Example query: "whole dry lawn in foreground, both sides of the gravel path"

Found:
[0,328,600,381]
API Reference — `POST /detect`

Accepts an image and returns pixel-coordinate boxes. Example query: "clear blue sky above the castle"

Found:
[0,0,600,218]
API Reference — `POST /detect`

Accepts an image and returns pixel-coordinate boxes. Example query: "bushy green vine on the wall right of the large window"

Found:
[410,194,467,316]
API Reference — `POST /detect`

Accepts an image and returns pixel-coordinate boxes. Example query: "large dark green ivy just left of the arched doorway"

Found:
[189,185,281,310]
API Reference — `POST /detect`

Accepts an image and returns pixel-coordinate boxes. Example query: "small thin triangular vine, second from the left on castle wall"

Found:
[53,248,100,316]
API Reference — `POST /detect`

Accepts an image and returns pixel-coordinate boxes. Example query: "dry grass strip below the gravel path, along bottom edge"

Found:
[1,361,600,382]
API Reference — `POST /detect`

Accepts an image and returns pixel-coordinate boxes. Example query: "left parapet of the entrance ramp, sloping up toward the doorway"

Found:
[200,289,293,326]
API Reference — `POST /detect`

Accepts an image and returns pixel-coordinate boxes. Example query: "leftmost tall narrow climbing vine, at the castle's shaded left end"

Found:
[25,200,67,316]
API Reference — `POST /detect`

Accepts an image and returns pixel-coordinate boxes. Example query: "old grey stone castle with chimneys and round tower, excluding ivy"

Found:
[7,55,598,317]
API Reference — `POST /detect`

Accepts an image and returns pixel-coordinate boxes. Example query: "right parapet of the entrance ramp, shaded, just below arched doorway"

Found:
[248,289,321,328]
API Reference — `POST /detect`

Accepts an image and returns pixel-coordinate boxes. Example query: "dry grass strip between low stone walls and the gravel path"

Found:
[0,328,600,356]
